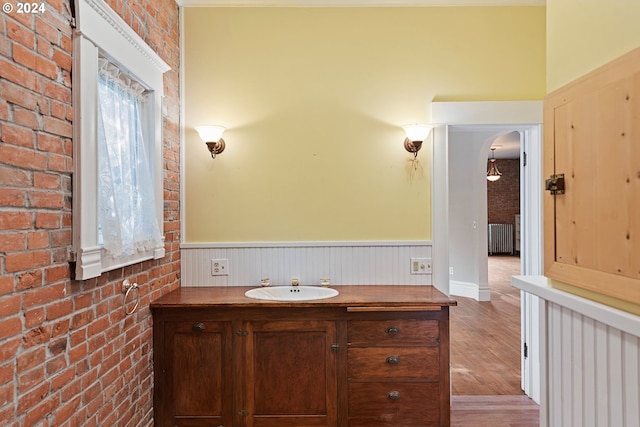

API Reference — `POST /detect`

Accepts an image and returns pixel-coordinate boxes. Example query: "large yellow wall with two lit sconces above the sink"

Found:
[184,7,546,242]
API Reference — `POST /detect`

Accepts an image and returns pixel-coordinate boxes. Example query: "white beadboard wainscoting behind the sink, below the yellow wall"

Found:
[181,241,431,286]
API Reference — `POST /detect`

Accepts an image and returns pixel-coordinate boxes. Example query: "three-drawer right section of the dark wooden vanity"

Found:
[347,310,450,427]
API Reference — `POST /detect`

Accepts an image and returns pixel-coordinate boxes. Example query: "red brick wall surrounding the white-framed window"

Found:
[0,0,180,427]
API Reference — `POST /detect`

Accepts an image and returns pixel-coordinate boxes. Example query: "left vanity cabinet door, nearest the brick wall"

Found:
[162,321,232,427]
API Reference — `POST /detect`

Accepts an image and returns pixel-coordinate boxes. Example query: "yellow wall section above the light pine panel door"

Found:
[547,0,640,92]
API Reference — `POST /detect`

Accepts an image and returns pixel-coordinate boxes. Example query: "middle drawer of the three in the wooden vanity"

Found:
[347,347,440,379]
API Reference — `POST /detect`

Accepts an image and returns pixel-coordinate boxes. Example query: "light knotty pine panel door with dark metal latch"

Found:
[544,49,640,304]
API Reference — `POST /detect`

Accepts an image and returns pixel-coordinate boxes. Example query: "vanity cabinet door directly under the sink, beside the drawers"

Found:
[243,320,337,427]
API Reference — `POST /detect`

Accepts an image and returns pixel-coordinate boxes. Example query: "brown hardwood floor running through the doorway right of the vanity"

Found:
[451,256,539,427]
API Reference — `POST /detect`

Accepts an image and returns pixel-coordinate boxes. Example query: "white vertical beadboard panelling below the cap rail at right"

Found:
[547,303,640,427]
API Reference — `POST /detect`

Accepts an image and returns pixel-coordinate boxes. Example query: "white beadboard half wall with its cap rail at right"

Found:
[512,276,640,427]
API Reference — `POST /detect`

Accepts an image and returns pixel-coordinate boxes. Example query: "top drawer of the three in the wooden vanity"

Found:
[347,319,440,346]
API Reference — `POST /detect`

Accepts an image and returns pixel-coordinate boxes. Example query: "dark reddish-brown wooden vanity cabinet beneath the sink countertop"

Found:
[152,289,455,427]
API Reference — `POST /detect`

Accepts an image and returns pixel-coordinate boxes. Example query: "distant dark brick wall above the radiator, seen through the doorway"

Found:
[487,159,520,230]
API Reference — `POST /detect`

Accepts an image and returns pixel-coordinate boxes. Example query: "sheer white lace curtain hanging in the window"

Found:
[98,58,162,258]
